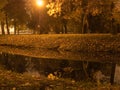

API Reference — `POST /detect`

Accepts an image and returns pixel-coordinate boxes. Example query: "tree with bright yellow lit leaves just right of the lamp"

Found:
[47,0,74,33]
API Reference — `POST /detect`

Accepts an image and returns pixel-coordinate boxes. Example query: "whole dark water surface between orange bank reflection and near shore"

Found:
[0,52,120,84]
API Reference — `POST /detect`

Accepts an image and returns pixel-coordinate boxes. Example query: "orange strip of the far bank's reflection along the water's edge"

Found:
[0,46,120,63]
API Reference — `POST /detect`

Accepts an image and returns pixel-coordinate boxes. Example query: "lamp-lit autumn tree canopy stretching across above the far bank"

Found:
[0,0,120,33]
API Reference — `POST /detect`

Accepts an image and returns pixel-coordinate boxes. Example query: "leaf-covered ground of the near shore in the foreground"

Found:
[0,65,120,90]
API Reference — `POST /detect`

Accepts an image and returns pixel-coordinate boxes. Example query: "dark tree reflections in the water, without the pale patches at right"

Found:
[0,53,115,83]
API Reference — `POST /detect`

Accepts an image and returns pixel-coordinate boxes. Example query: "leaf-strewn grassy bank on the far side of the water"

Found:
[0,34,120,52]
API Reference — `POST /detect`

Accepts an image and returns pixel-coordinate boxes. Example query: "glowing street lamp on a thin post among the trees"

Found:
[36,0,44,33]
